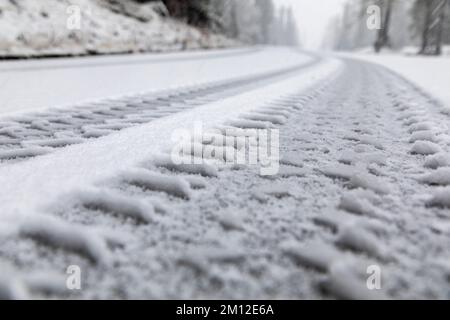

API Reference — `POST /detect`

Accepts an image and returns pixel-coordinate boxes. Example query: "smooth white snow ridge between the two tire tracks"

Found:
[0,54,340,219]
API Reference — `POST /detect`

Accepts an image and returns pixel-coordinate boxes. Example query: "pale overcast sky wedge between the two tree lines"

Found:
[275,0,346,49]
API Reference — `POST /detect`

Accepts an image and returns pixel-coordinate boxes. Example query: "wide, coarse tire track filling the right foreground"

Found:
[0,56,450,299]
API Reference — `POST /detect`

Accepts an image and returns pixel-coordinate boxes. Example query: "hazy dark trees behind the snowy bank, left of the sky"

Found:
[136,0,299,46]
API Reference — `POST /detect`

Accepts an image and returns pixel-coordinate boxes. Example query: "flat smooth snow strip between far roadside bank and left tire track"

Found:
[0,48,312,116]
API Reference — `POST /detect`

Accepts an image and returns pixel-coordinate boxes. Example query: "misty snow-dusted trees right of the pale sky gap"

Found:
[327,0,450,55]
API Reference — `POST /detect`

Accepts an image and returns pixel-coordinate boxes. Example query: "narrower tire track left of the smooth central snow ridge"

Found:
[0,57,320,162]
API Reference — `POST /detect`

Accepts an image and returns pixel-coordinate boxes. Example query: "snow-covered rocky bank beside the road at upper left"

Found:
[0,0,236,57]
